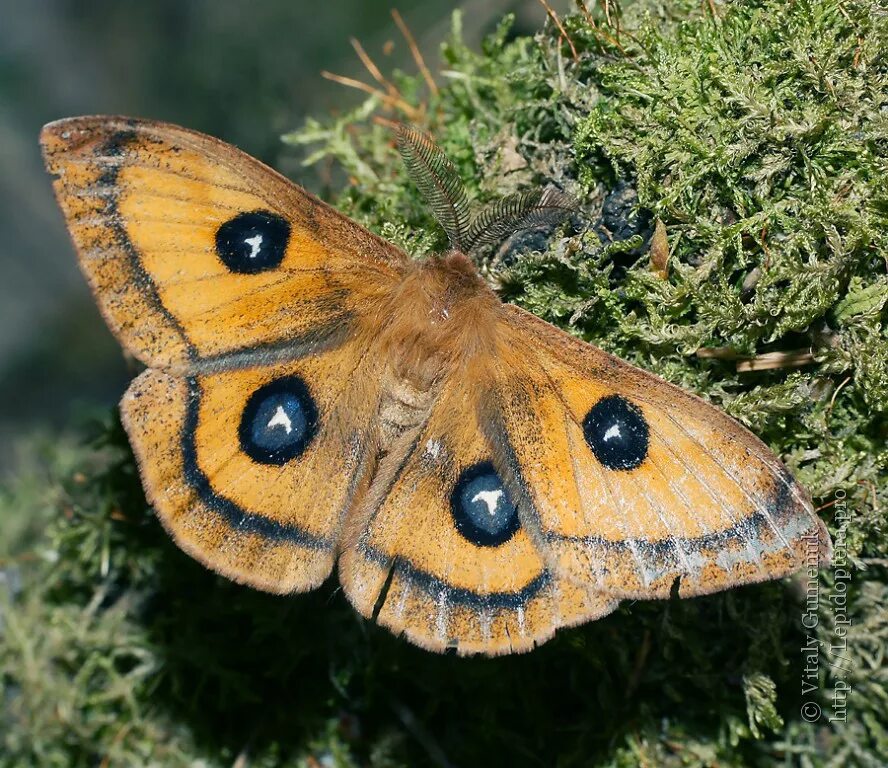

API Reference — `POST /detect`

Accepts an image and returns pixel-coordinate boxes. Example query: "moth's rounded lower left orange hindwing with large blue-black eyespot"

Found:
[121,342,380,593]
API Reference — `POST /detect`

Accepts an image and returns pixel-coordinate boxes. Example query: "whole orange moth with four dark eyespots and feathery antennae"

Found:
[41,117,831,655]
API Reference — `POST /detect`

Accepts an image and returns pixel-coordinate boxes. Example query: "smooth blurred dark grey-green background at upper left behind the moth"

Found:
[0,0,570,478]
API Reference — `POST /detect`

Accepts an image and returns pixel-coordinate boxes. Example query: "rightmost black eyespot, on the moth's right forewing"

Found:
[583,395,650,470]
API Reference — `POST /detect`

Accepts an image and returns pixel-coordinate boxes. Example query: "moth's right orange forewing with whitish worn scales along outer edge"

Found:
[488,307,831,598]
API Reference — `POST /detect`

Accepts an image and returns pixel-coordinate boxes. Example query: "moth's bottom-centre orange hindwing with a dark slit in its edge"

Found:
[339,368,616,655]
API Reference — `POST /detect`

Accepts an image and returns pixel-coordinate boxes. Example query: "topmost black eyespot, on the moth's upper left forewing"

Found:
[216,211,290,274]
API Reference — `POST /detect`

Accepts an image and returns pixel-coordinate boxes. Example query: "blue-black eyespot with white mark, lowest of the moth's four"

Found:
[450,461,521,547]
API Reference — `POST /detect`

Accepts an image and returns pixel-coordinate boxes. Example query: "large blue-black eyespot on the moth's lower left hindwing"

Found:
[239,376,318,465]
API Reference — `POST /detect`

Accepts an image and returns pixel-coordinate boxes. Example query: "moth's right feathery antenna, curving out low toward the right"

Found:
[465,187,577,251]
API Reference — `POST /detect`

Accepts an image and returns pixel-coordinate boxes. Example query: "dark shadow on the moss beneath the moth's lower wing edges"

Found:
[6,425,802,765]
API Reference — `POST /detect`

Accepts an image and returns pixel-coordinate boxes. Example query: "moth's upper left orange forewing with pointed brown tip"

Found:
[40,117,406,371]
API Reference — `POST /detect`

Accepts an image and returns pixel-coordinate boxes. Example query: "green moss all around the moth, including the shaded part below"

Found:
[0,0,888,766]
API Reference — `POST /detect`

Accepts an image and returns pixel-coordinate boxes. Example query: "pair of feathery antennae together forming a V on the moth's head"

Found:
[397,124,577,254]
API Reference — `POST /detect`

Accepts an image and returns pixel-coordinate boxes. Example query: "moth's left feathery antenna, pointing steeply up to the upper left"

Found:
[398,125,469,251]
